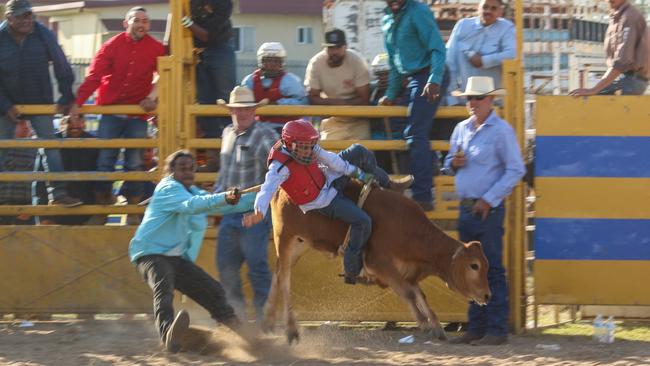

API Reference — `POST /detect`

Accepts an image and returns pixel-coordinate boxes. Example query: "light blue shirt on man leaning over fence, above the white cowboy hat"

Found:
[447,17,517,105]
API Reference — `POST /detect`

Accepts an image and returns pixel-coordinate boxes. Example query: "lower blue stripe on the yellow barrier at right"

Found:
[535,217,650,260]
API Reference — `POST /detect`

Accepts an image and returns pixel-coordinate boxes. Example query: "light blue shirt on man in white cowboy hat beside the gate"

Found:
[445,112,525,207]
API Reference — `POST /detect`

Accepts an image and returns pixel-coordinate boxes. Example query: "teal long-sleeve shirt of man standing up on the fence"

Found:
[381,0,445,99]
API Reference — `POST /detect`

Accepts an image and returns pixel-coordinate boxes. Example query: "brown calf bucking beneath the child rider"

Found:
[264,183,491,343]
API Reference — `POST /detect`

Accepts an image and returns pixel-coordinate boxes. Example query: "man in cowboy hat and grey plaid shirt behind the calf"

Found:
[215,86,279,320]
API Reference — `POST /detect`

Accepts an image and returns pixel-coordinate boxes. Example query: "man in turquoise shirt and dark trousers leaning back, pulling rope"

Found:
[129,150,255,352]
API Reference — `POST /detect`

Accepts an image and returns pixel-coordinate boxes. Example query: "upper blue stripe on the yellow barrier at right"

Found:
[535,136,650,178]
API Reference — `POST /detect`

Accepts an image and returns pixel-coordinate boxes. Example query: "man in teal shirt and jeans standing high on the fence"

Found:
[380,0,445,211]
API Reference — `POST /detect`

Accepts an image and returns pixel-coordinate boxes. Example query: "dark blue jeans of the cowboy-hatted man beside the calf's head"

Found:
[458,204,509,336]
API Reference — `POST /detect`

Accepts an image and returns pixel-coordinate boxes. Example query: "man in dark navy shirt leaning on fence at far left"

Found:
[0,0,83,207]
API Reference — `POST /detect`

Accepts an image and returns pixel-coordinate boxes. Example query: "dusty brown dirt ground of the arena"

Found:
[0,320,650,366]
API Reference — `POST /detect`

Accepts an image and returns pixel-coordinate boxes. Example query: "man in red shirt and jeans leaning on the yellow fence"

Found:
[71,7,165,225]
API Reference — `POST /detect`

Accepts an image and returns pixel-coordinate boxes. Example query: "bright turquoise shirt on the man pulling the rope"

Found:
[129,176,255,262]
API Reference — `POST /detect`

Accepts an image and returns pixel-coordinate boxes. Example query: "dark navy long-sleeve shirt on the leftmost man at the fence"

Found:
[0,21,74,115]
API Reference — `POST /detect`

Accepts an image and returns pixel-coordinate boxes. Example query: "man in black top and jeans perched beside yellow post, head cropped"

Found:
[181,0,237,142]
